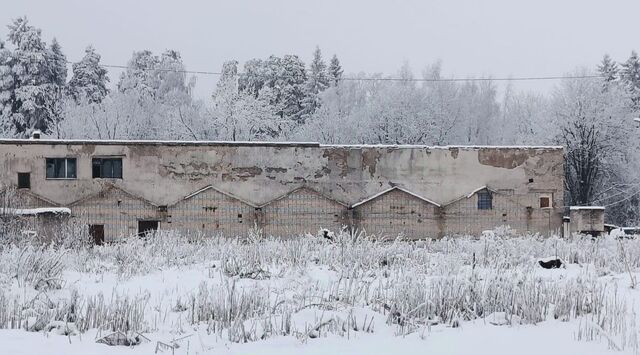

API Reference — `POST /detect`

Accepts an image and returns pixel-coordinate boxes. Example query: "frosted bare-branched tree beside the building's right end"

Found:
[552,71,629,205]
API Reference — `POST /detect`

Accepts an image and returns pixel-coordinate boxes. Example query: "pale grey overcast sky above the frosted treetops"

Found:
[0,0,640,97]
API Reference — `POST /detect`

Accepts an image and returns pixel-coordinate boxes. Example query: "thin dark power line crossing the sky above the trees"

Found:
[67,61,604,82]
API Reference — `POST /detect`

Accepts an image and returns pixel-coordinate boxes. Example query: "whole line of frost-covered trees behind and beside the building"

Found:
[0,17,640,224]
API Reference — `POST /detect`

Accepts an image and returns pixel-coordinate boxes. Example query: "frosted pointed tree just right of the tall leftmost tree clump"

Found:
[67,46,109,104]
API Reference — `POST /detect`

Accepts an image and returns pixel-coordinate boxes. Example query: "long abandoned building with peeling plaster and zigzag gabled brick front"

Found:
[0,139,564,241]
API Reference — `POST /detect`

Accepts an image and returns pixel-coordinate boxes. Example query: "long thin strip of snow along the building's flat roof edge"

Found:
[0,138,563,149]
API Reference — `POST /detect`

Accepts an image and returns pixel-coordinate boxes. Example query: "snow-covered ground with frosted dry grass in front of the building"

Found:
[0,230,640,355]
